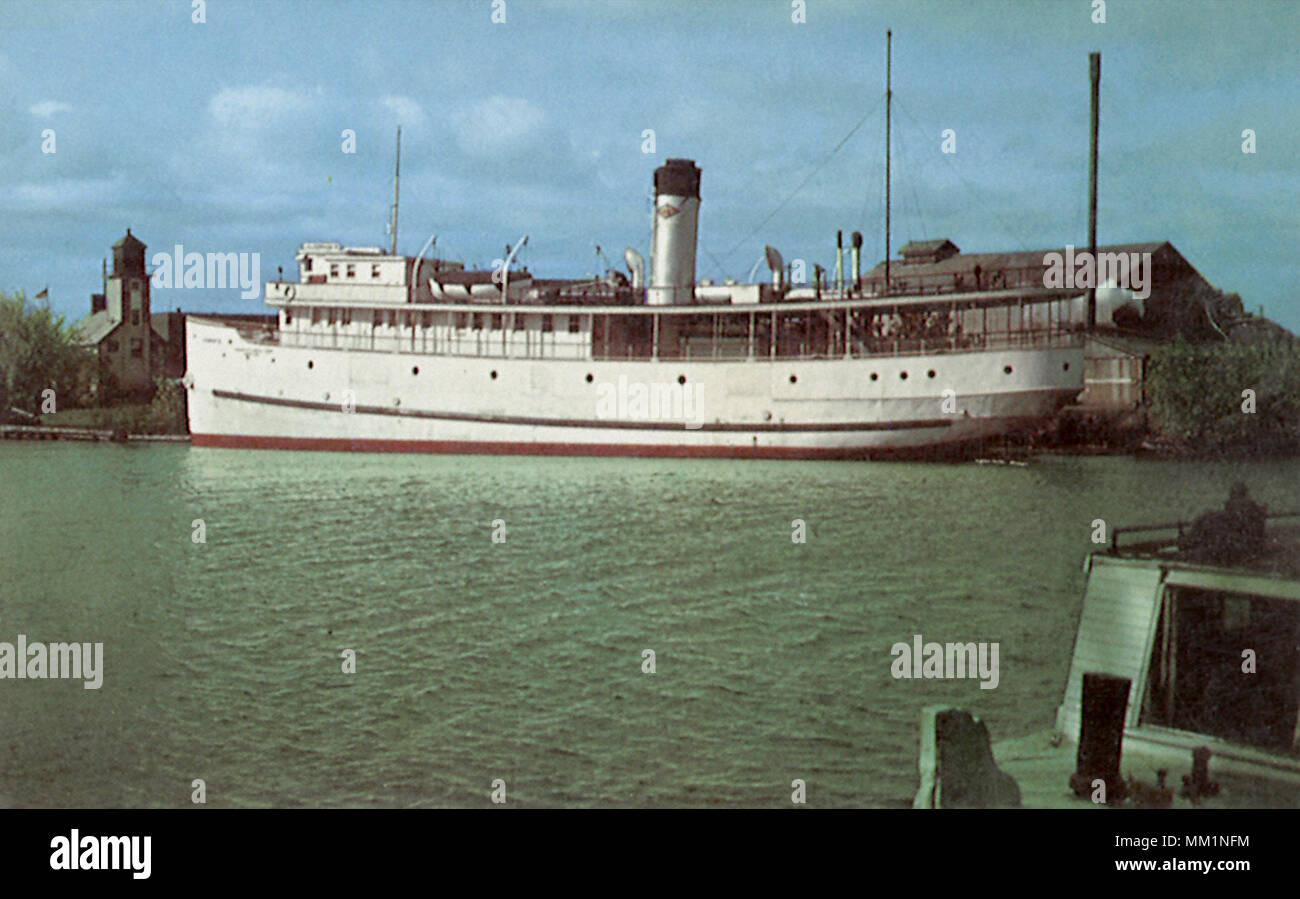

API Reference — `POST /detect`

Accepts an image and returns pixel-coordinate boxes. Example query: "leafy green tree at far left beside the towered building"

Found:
[0,291,86,412]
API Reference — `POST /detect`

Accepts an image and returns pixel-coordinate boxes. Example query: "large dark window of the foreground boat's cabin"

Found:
[1141,587,1300,756]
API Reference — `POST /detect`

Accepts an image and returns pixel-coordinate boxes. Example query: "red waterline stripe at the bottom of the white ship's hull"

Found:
[191,434,975,459]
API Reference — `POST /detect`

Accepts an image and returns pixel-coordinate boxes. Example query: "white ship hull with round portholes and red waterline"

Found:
[186,317,1083,457]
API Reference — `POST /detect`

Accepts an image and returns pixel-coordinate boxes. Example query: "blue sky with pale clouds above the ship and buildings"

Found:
[0,0,1300,330]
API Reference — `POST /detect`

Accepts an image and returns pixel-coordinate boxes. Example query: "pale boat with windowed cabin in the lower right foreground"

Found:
[914,485,1300,808]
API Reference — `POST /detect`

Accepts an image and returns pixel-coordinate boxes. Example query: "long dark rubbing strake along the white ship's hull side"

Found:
[212,390,953,434]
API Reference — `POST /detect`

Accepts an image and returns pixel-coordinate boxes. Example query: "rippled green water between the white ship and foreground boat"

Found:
[0,443,1300,807]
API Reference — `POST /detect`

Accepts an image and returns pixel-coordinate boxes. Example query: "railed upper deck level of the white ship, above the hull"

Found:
[248,274,1082,361]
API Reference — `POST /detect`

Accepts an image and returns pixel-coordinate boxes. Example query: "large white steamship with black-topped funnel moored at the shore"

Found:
[185,36,1095,459]
